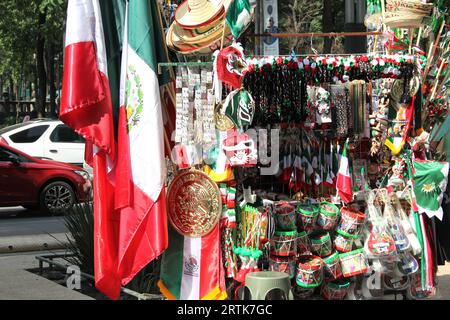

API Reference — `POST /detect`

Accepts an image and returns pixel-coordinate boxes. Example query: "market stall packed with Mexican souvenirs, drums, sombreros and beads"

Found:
[159,0,450,300]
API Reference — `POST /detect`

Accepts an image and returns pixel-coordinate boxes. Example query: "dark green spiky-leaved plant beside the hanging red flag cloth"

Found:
[64,202,94,275]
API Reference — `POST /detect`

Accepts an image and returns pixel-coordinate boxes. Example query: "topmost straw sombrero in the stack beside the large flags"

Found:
[175,0,228,28]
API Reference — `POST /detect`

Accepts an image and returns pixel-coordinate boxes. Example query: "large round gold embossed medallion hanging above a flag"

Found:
[167,171,222,238]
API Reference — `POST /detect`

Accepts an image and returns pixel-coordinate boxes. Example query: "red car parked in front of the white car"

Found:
[0,141,91,214]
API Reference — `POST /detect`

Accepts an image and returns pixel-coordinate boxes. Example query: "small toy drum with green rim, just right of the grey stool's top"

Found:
[296,256,323,288]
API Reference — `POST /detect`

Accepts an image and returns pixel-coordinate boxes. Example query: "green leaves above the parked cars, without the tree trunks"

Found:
[0,0,68,97]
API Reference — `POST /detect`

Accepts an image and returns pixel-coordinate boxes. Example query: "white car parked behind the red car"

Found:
[0,119,84,167]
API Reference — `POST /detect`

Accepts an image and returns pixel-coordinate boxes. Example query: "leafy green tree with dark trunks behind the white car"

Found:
[0,0,67,116]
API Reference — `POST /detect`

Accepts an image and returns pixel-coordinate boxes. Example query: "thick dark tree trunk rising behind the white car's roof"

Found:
[36,13,47,117]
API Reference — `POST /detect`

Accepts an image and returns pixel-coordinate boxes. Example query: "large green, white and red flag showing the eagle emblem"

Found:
[115,0,168,285]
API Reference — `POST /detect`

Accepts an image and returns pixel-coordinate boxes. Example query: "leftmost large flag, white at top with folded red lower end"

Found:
[59,0,116,159]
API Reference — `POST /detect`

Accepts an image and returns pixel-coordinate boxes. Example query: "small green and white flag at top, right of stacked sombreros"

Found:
[226,0,253,39]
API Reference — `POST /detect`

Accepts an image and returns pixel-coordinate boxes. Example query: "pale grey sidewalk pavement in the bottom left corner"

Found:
[0,252,94,300]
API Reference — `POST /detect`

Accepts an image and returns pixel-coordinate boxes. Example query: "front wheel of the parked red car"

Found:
[40,181,75,214]
